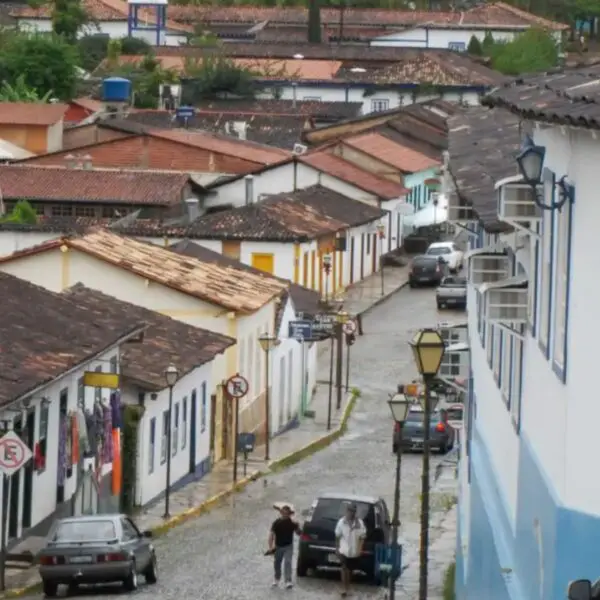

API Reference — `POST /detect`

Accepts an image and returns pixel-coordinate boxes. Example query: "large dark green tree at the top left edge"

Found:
[0,32,79,100]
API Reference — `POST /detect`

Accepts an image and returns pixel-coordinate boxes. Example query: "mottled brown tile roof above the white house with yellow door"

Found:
[185,185,387,242]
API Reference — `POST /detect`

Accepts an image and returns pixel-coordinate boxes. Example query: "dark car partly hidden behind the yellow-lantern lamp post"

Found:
[393,405,454,454]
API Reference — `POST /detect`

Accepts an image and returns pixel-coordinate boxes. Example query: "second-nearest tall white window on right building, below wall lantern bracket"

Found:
[537,169,555,358]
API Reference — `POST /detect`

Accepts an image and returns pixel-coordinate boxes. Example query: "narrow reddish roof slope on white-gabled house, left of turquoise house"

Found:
[299,151,408,200]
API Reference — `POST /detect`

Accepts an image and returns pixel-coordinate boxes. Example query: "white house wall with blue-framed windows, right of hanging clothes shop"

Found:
[136,362,214,506]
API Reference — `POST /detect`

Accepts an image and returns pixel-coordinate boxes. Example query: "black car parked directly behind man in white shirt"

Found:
[296,493,391,583]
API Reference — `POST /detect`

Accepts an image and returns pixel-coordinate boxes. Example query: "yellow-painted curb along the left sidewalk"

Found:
[0,394,359,599]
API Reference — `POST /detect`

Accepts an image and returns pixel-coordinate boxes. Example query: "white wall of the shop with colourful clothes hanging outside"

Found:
[0,347,119,537]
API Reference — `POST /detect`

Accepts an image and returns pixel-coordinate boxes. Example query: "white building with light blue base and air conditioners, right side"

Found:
[445,71,600,600]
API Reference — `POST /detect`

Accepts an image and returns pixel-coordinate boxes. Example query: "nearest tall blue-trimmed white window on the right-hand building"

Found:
[552,202,572,382]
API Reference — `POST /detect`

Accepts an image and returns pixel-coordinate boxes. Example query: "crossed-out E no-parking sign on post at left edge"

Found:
[0,431,32,592]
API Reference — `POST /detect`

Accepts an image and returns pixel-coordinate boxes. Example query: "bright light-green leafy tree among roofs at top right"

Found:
[490,28,559,75]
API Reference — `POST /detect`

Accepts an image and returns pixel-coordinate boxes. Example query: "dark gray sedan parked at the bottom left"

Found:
[38,515,158,598]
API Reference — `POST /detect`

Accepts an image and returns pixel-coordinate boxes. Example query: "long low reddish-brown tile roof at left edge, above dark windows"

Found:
[0,165,191,206]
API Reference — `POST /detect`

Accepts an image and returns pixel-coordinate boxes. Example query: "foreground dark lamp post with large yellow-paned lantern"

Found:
[410,329,446,600]
